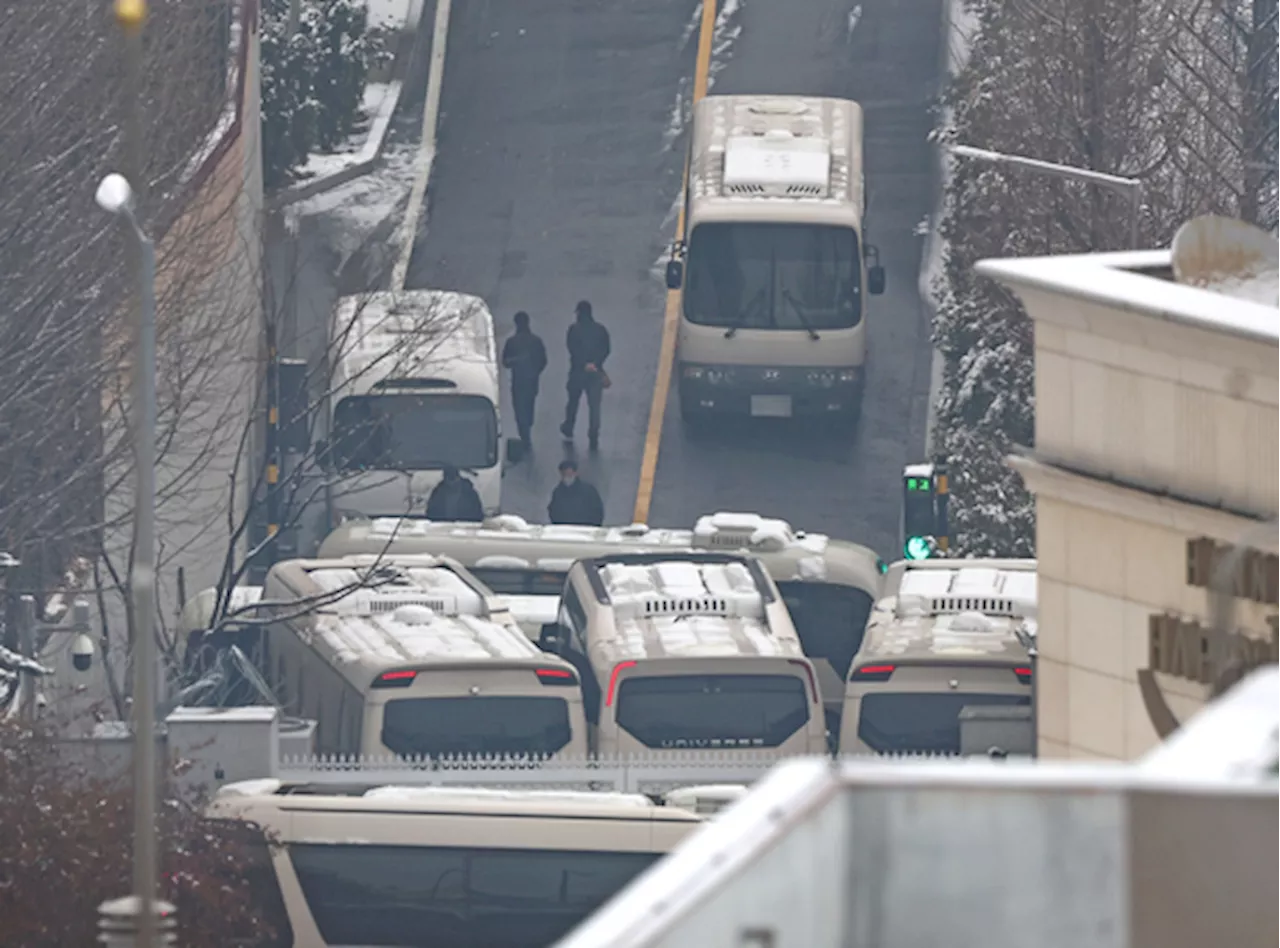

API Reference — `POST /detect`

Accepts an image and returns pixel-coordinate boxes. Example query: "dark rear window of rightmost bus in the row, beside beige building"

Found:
[858,692,1032,754]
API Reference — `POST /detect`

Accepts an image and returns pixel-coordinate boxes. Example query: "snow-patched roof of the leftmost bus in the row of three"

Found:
[266,557,556,681]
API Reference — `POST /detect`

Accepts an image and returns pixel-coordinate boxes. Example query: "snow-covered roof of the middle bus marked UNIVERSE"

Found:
[598,559,800,658]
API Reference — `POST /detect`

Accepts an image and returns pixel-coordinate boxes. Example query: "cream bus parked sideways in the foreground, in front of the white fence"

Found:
[209,780,703,948]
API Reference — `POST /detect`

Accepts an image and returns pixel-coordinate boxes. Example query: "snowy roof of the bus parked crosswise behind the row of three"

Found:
[320,512,881,597]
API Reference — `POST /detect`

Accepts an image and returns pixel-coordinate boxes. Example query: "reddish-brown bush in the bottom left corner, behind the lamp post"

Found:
[0,725,291,948]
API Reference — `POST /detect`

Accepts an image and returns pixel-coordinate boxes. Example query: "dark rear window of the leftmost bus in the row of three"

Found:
[383,695,572,757]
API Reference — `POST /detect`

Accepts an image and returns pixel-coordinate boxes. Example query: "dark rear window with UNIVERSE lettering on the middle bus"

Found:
[616,674,809,750]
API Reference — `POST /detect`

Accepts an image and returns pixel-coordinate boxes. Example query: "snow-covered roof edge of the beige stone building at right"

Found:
[974,251,1280,345]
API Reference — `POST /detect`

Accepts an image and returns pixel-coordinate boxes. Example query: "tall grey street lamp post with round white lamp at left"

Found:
[97,168,156,948]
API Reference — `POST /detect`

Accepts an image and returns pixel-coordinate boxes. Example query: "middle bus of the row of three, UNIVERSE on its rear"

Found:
[556,553,840,757]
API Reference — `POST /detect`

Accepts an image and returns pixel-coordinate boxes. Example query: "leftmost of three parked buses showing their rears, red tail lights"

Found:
[266,557,588,757]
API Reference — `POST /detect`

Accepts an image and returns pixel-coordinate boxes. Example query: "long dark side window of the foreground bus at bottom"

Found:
[289,844,660,948]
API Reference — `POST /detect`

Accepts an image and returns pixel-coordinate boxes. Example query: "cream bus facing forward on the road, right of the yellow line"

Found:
[667,95,884,421]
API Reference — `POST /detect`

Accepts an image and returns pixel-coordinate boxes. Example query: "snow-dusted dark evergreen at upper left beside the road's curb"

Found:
[260,0,388,188]
